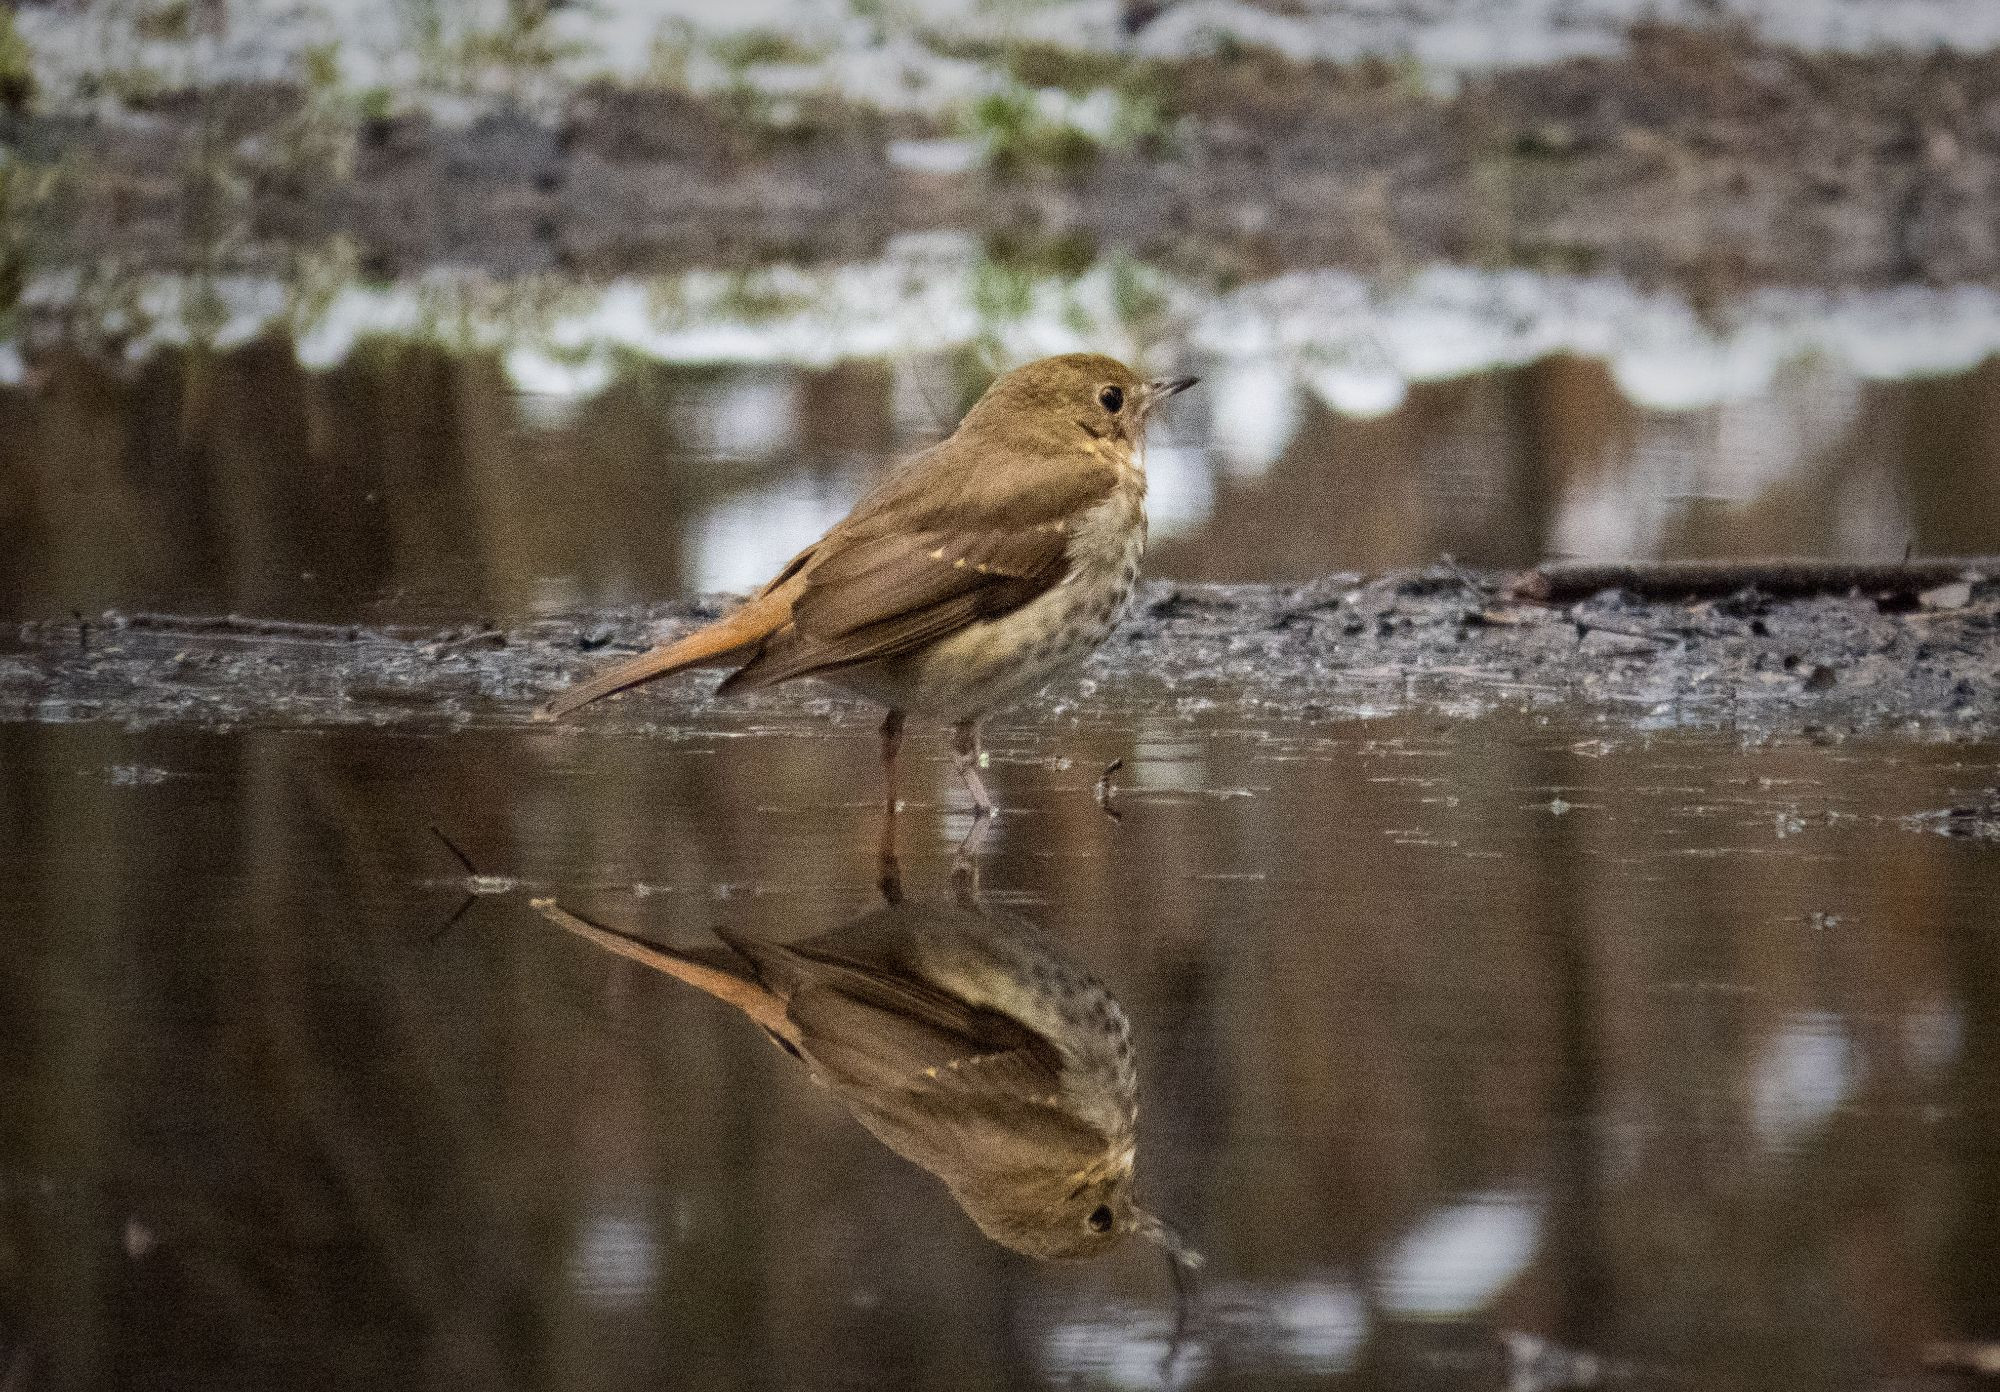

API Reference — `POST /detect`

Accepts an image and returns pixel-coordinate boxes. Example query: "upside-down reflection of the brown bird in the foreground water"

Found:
[534,876,1198,1284]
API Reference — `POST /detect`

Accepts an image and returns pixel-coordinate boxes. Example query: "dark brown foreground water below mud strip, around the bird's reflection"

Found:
[0,710,2000,1388]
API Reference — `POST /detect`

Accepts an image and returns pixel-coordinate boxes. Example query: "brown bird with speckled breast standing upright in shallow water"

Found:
[536,352,1196,816]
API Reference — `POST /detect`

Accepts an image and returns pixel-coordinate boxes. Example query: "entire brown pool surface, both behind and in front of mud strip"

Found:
[11,242,2000,1392]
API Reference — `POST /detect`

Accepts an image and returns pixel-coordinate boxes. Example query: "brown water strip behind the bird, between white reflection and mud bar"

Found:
[0,314,2000,626]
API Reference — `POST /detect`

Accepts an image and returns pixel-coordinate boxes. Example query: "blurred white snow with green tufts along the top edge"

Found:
[14,0,2000,128]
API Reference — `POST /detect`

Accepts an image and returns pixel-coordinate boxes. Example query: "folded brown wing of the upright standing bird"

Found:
[726,442,1118,688]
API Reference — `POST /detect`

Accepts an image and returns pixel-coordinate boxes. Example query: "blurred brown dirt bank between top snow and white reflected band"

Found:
[11,28,2000,288]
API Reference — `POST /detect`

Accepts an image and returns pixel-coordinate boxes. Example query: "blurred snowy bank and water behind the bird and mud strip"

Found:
[0,0,2000,622]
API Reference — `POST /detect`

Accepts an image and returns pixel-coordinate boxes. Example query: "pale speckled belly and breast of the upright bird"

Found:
[824,508,1146,722]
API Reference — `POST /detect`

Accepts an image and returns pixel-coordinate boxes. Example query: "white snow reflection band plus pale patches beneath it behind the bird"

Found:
[0,247,2000,568]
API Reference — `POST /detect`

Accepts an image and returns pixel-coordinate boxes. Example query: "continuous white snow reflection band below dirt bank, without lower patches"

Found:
[27,246,2000,418]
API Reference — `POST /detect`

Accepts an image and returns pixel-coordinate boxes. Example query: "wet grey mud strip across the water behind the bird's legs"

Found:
[0,564,2000,740]
